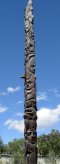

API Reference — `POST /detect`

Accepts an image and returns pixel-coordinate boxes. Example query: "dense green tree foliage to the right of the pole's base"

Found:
[37,129,60,157]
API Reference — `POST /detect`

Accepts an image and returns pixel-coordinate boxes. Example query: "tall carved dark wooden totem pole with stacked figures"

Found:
[23,0,37,164]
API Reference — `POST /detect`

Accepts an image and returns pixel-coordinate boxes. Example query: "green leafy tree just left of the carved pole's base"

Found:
[8,139,24,164]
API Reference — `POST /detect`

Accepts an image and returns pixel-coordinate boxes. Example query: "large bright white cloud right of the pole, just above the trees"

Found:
[37,104,60,130]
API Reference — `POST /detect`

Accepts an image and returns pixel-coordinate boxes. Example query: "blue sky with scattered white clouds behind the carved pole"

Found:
[0,0,60,143]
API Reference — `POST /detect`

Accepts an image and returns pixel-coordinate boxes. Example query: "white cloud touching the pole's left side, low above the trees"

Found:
[5,119,24,133]
